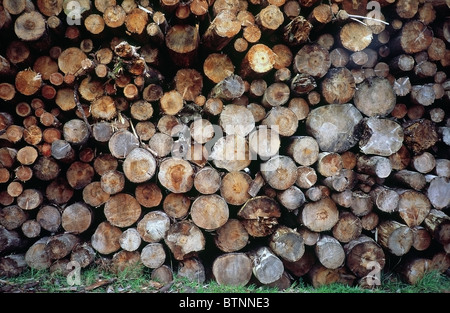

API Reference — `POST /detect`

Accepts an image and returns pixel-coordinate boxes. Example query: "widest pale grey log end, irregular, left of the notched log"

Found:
[306,103,363,153]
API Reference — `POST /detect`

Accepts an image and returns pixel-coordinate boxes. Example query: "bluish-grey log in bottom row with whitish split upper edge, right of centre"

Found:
[247,246,284,284]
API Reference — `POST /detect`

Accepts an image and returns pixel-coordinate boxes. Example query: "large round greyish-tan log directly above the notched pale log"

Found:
[354,76,397,117]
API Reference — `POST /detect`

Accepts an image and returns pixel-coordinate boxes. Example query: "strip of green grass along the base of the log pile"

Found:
[0,268,450,293]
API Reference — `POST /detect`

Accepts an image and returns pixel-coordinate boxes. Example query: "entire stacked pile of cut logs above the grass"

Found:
[0,0,450,288]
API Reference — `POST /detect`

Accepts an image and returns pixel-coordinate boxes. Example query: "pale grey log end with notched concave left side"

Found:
[359,117,404,156]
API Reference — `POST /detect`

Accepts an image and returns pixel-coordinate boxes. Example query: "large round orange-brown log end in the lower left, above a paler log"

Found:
[104,192,142,227]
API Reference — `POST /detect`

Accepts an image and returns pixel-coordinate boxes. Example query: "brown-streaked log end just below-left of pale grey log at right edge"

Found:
[398,190,431,228]
